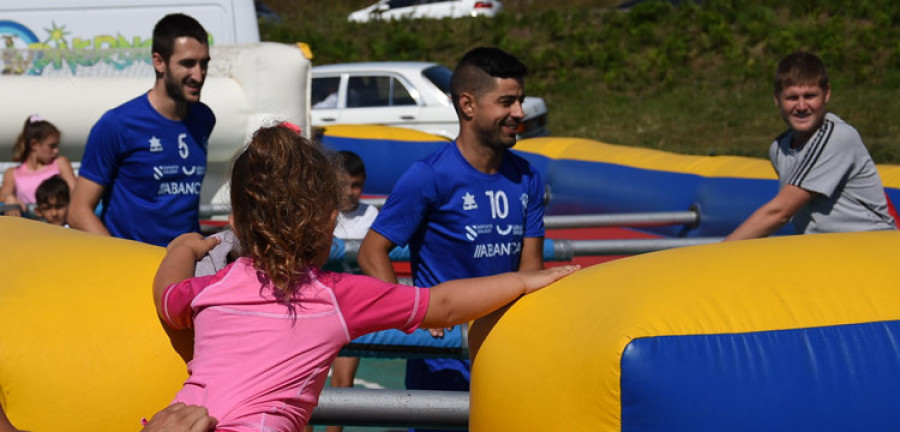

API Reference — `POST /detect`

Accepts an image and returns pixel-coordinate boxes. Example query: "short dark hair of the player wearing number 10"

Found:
[450,47,528,110]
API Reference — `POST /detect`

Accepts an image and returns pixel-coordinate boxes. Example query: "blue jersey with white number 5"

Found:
[78,94,216,246]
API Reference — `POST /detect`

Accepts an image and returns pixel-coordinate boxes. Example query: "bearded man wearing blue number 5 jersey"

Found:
[69,14,216,246]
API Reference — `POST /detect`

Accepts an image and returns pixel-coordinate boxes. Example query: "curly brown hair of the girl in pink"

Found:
[231,126,340,303]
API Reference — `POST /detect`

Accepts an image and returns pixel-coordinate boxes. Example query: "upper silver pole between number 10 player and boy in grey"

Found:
[544,211,700,229]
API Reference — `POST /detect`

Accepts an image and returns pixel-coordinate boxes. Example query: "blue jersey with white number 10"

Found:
[372,143,544,287]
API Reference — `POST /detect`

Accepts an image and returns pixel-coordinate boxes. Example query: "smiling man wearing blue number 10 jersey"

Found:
[359,48,544,430]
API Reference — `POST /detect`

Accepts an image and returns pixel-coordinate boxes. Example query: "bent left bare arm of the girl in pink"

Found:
[153,233,219,315]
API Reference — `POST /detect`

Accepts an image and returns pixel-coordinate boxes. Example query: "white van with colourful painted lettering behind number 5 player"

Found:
[0,0,259,76]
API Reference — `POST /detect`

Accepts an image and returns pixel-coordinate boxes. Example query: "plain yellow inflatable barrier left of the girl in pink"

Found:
[0,221,187,432]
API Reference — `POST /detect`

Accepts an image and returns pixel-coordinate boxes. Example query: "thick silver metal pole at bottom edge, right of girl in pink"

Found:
[309,387,469,429]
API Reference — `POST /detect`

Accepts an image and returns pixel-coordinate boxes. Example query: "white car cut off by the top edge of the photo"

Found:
[347,0,503,22]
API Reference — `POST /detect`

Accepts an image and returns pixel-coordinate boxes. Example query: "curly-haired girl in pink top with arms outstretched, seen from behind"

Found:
[153,126,577,431]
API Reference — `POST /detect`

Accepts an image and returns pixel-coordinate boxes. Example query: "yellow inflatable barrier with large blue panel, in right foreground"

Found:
[470,232,900,432]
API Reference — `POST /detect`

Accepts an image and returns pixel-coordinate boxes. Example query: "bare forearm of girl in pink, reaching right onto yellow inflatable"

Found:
[420,265,581,328]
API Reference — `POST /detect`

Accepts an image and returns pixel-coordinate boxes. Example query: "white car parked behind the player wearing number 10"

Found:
[310,62,548,139]
